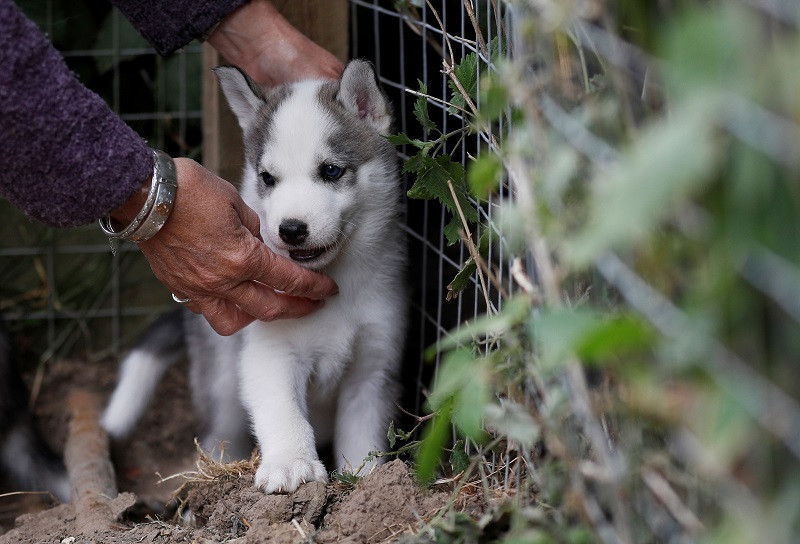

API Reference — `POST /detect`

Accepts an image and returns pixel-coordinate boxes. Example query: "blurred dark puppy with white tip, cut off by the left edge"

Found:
[0,318,70,501]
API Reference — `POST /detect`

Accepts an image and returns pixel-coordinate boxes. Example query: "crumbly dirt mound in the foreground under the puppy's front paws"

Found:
[0,461,447,544]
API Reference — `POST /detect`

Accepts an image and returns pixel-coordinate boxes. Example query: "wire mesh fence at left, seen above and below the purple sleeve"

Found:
[0,0,202,361]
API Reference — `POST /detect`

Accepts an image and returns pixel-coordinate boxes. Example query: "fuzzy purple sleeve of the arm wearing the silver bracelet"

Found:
[0,0,153,227]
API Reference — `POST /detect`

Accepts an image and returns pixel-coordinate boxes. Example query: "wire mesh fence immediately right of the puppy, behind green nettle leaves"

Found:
[351,0,511,413]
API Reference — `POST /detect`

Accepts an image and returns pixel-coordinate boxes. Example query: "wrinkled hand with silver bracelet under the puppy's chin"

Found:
[139,159,338,335]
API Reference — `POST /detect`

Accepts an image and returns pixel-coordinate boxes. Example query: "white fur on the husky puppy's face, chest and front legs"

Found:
[227,61,405,492]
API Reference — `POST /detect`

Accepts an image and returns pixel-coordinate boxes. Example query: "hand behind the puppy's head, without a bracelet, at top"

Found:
[207,0,344,86]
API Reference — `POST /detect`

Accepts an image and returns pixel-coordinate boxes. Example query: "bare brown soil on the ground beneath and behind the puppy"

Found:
[0,361,456,544]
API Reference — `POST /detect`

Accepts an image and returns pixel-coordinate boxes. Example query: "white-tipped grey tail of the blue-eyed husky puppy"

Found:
[100,308,186,440]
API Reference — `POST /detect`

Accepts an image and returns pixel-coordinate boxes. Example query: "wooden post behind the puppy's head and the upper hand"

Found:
[203,0,349,185]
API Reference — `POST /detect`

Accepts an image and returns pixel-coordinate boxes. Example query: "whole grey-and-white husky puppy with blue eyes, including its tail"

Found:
[103,60,406,493]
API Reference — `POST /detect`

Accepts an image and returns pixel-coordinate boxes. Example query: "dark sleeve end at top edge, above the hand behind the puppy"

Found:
[111,0,249,55]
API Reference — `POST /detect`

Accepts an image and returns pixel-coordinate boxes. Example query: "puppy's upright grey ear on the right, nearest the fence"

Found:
[339,59,392,135]
